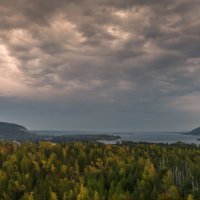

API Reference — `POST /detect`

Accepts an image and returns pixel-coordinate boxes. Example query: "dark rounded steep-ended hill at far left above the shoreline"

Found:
[0,122,29,138]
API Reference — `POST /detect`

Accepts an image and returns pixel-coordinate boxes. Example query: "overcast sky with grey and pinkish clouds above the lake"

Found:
[0,0,200,131]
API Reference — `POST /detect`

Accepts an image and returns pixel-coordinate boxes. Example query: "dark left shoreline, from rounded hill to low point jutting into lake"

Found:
[0,122,120,142]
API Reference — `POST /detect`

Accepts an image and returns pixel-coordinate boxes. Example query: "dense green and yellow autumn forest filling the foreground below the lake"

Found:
[0,142,200,200]
